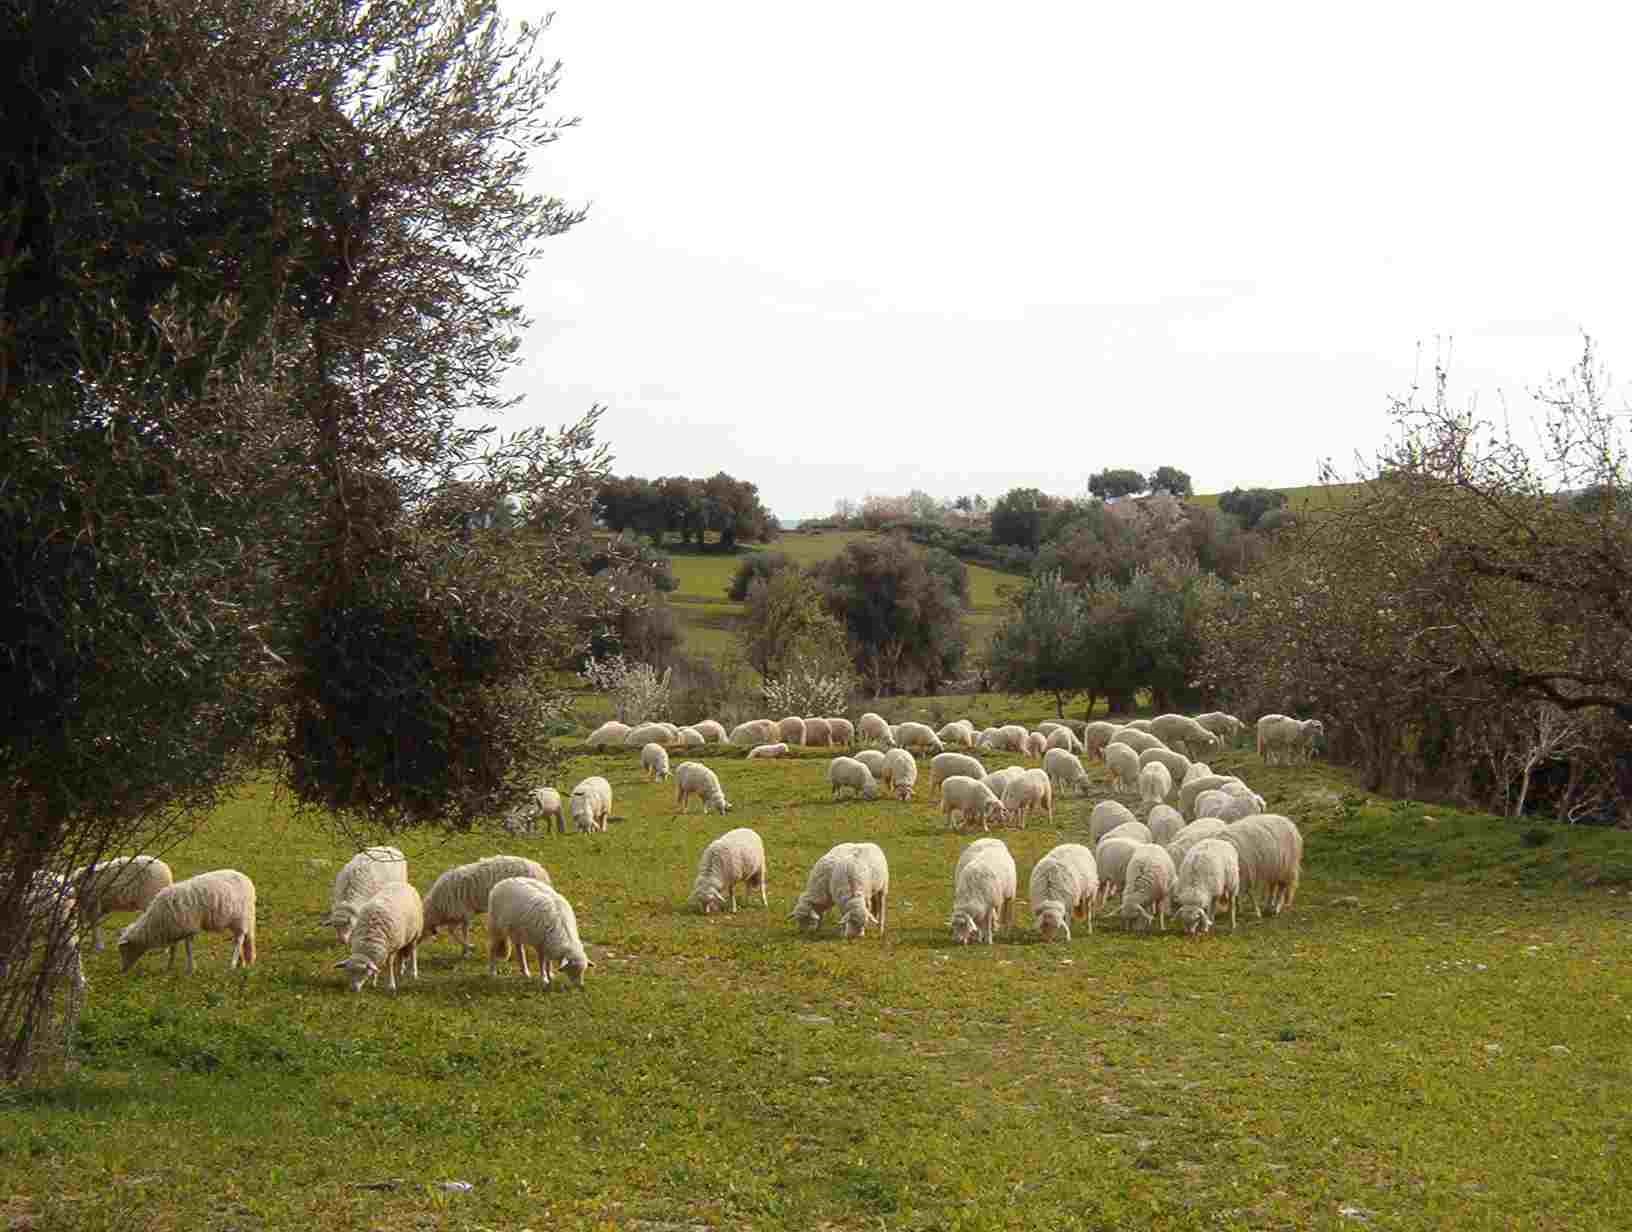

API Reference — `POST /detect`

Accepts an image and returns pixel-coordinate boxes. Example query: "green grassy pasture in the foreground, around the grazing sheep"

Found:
[0,737,1632,1232]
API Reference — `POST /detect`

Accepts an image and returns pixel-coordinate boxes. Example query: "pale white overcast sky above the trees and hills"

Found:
[504,0,1632,521]
